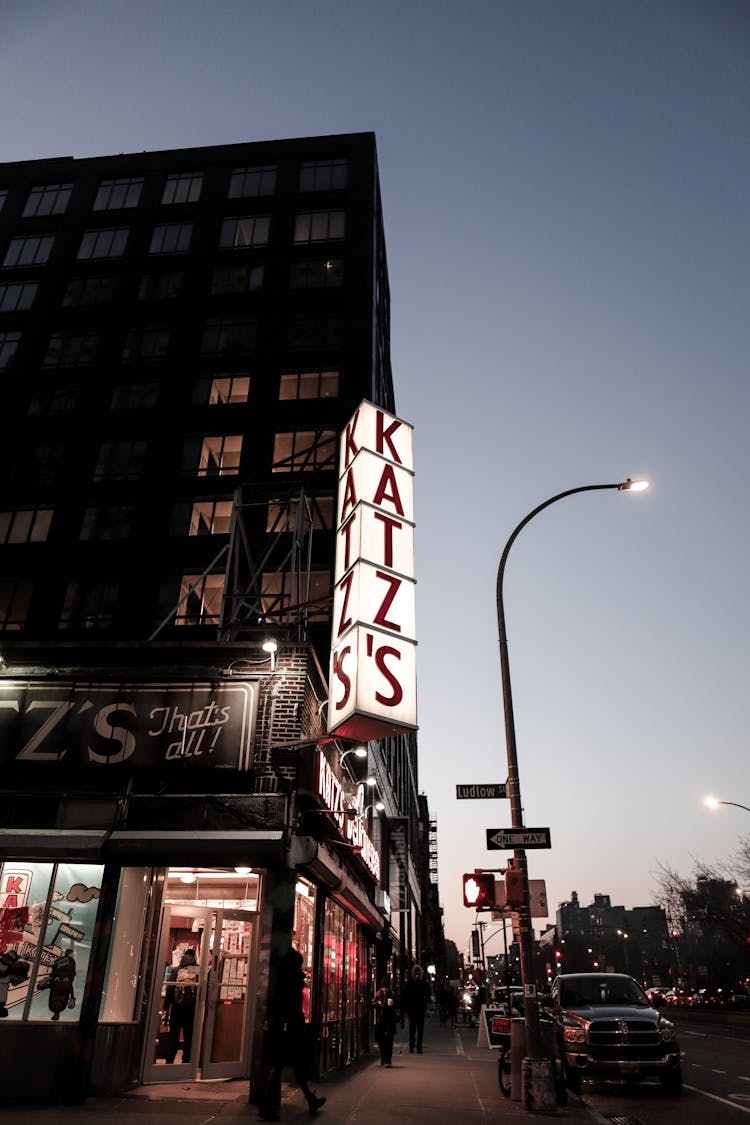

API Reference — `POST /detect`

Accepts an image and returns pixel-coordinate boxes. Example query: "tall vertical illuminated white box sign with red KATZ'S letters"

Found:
[328,402,417,741]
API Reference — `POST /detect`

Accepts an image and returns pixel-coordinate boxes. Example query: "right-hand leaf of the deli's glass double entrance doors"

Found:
[201,910,255,1078]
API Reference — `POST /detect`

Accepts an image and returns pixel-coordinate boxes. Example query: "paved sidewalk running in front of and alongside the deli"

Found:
[1,1015,597,1125]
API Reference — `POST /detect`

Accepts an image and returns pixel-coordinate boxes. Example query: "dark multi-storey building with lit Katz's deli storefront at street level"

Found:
[0,134,434,1100]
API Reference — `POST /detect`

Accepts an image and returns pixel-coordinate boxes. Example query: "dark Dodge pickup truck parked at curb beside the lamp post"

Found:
[548,973,683,1096]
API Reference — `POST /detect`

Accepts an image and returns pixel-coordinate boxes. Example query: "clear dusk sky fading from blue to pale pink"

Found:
[0,0,750,953]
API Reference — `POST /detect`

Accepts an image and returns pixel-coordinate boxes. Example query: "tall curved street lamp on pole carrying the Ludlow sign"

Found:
[497,477,649,1113]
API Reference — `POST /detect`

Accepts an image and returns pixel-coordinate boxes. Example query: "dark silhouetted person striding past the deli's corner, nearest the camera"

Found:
[259,947,326,1122]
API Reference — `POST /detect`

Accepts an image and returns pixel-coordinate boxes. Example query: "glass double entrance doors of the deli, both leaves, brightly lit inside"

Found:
[143,903,256,1082]
